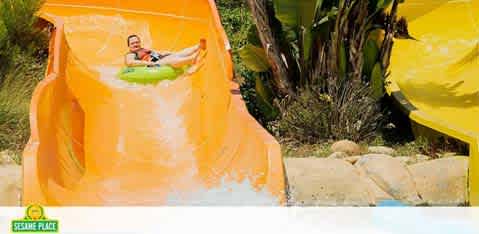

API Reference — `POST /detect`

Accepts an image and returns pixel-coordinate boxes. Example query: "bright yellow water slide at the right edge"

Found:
[387,0,479,206]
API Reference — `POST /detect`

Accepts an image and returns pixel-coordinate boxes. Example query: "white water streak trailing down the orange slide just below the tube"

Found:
[96,66,196,168]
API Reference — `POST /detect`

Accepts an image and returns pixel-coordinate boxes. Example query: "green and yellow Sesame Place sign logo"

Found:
[12,205,58,233]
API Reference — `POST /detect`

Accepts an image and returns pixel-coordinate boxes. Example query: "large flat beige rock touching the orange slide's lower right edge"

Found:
[285,158,374,206]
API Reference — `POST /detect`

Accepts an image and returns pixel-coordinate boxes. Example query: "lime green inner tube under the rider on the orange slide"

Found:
[118,65,188,84]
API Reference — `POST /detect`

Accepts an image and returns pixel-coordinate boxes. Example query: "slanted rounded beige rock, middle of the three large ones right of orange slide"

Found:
[355,154,422,205]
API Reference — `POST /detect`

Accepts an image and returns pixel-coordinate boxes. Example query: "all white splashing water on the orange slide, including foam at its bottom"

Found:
[92,66,280,206]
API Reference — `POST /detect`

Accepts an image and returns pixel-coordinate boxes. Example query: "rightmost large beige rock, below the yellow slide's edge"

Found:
[409,157,469,206]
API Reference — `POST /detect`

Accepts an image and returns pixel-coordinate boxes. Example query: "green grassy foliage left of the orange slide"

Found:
[0,0,48,153]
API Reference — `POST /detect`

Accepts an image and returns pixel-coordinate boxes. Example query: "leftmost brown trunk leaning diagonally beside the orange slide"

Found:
[248,0,294,97]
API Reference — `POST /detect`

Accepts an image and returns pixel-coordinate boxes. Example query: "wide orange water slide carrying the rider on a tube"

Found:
[22,0,286,206]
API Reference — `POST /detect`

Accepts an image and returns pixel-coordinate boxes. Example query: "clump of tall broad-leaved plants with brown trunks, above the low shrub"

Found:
[240,0,412,141]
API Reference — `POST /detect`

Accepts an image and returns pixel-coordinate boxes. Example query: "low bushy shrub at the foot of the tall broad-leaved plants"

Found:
[278,80,382,143]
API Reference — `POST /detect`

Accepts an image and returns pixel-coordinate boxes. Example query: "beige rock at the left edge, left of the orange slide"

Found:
[0,165,22,206]
